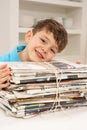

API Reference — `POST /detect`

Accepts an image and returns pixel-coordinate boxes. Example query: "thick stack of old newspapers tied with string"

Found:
[0,61,87,118]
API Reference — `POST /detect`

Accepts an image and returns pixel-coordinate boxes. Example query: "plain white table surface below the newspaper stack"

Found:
[0,107,87,130]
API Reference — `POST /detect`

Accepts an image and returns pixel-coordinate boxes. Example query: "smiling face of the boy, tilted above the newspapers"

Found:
[27,30,58,62]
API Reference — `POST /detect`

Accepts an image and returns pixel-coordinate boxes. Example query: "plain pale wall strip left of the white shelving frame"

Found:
[0,0,10,55]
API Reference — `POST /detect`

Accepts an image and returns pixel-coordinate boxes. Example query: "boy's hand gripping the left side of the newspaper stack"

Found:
[0,64,11,89]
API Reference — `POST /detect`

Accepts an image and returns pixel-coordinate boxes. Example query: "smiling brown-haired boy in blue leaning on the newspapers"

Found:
[0,19,67,88]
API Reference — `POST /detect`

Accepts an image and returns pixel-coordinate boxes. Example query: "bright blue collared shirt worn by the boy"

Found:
[0,45,25,62]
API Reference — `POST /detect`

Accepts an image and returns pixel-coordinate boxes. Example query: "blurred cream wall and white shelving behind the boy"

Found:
[0,0,87,64]
